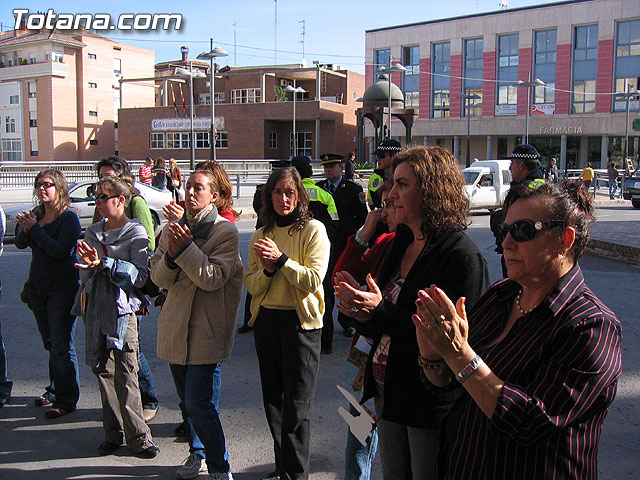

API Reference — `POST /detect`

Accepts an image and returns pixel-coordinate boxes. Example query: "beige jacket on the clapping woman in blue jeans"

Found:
[151,208,243,365]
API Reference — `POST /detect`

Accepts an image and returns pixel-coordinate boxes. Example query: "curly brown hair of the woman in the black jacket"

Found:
[393,146,469,235]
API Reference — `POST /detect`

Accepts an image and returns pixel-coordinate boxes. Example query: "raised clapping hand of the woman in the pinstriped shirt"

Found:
[412,285,470,360]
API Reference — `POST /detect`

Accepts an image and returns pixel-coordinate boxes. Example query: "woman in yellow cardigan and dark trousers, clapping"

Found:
[245,168,330,479]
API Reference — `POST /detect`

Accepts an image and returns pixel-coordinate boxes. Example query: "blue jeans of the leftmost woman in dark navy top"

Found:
[27,284,80,412]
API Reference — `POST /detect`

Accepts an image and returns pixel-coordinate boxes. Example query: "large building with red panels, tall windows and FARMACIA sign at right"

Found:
[365,0,640,169]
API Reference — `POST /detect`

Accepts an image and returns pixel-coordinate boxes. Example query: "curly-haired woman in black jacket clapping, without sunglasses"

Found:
[335,147,489,480]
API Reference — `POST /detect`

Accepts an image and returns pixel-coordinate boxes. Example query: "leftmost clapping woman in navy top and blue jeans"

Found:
[15,169,81,418]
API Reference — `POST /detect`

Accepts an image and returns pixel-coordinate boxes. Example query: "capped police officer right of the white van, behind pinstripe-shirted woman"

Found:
[490,143,546,277]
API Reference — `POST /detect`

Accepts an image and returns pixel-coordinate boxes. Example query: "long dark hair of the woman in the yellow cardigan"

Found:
[260,167,311,235]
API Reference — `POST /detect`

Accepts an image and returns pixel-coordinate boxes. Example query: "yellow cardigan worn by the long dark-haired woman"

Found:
[244,220,331,330]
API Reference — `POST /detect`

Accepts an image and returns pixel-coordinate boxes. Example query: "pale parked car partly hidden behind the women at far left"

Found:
[5,180,172,236]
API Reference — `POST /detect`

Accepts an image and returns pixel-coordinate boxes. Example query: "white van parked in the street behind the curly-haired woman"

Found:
[462,160,511,211]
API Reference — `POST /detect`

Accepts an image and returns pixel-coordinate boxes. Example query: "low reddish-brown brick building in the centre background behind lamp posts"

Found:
[119,49,364,160]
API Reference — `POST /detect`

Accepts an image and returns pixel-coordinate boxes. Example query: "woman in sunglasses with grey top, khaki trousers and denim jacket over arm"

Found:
[76,176,160,458]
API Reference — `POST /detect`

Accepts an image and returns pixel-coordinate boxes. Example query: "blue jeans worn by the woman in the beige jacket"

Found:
[169,363,230,473]
